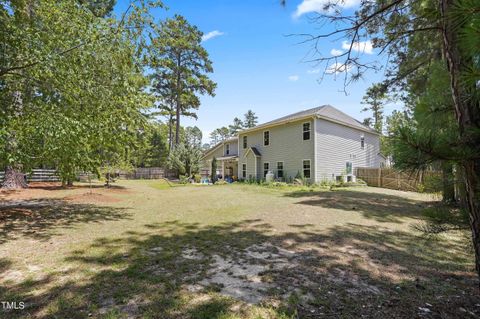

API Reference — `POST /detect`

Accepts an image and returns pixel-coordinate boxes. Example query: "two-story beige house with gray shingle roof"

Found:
[204,105,382,183]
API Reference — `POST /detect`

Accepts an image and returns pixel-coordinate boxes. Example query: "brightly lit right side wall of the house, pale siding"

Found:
[312,119,380,182]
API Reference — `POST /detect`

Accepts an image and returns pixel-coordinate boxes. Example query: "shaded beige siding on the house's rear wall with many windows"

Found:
[238,119,315,181]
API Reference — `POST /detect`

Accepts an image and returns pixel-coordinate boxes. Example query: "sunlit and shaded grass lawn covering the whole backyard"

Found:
[0,181,480,319]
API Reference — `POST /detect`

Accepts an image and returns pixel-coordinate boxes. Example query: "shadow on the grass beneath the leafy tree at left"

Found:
[0,199,129,243]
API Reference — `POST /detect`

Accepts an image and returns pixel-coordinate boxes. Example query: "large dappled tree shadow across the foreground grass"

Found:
[0,220,480,319]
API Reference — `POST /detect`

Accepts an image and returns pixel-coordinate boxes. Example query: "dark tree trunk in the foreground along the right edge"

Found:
[439,0,480,277]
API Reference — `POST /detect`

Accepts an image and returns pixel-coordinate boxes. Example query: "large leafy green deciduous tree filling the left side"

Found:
[0,0,159,187]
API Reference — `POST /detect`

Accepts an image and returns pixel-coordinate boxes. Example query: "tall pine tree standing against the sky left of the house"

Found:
[150,15,216,145]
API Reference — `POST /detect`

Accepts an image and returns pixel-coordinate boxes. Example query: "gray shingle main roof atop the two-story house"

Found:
[240,105,376,133]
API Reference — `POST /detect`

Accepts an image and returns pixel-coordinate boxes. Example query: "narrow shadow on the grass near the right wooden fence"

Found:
[285,190,428,222]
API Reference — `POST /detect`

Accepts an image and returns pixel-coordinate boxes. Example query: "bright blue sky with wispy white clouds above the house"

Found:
[116,0,398,141]
